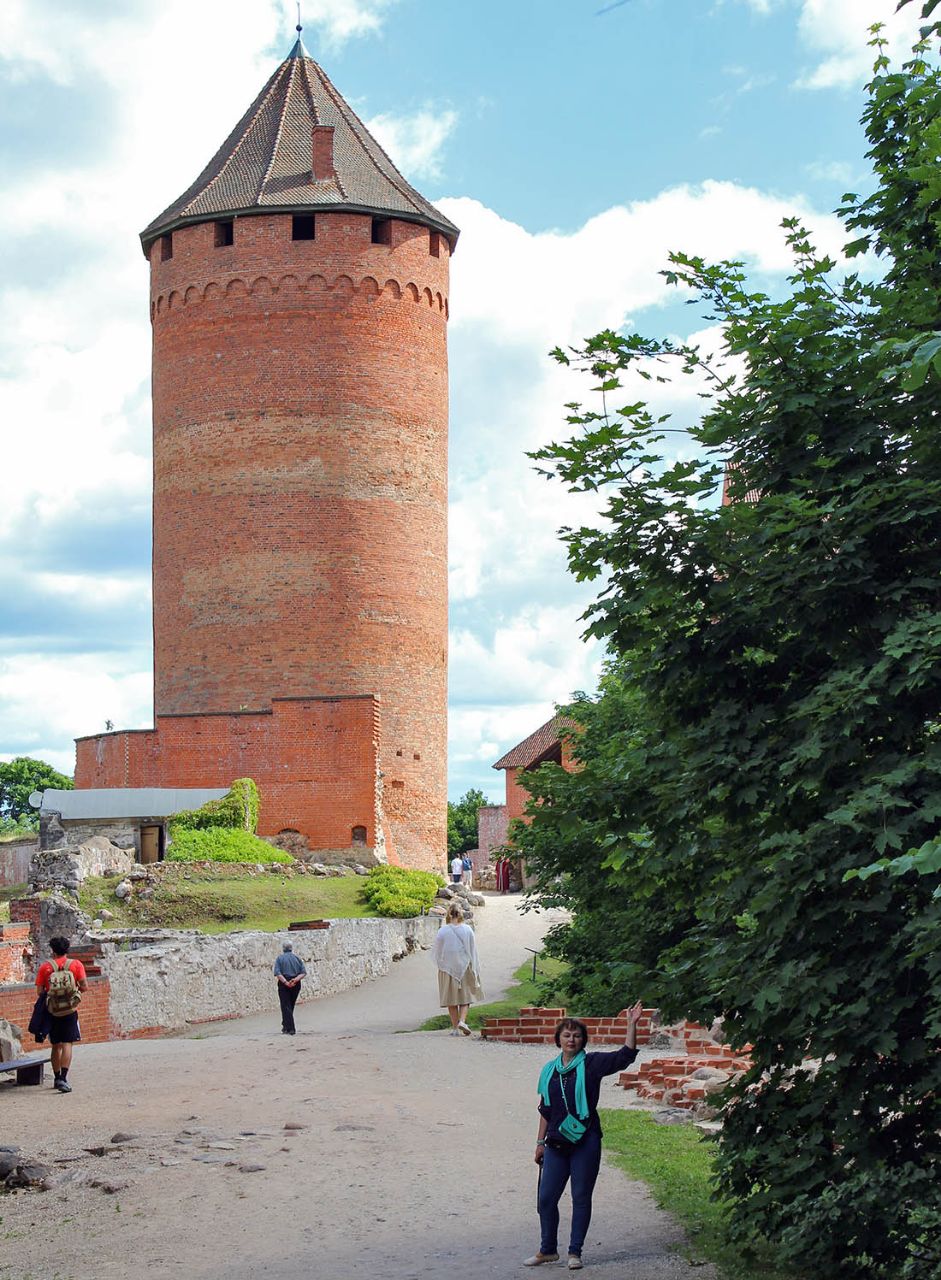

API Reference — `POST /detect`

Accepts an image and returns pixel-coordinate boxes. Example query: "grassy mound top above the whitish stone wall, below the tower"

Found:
[79,863,375,933]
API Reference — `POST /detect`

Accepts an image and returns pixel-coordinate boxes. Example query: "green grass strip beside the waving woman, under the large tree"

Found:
[600,1111,800,1280]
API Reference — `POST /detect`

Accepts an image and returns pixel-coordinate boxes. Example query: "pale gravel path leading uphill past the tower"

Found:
[0,897,714,1280]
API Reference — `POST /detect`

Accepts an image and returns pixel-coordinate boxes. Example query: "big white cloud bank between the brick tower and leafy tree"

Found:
[439,182,842,795]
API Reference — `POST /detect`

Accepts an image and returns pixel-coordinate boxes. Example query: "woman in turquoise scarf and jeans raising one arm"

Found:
[524,1001,643,1271]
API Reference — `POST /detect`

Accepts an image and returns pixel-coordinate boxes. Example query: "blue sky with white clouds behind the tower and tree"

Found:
[0,0,915,800]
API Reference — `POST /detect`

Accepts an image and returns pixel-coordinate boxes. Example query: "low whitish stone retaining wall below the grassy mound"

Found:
[0,916,440,1047]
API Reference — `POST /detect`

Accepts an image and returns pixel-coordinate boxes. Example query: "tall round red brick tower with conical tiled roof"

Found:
[77,40,457,867]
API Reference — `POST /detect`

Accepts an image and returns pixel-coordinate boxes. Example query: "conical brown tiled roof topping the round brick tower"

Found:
[141,40,458,253]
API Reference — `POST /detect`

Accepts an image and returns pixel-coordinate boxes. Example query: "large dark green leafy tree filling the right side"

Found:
[516,27,941,1280]
